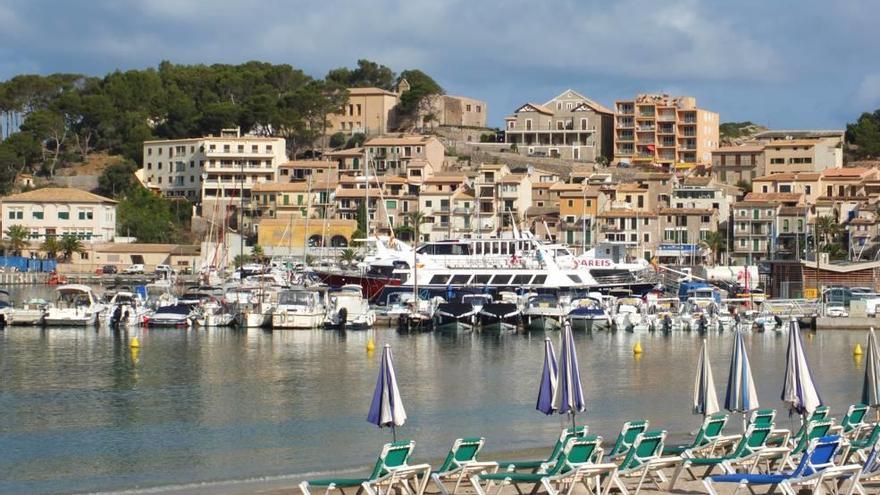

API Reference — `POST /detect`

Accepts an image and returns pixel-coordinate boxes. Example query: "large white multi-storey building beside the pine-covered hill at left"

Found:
[140,129,287,208]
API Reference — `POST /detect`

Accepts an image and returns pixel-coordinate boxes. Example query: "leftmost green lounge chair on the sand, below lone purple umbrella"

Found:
[299,440,431,495]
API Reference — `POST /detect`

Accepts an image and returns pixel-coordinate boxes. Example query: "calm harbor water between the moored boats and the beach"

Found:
[0,286,866,494]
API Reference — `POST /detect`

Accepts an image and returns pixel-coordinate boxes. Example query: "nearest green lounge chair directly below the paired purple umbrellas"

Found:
[471,435,617,495]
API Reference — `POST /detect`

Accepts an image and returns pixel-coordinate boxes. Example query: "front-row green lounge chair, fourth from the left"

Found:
[606,430,682,495]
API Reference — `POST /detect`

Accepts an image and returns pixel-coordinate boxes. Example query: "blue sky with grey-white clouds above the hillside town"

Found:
[0,0,880,129]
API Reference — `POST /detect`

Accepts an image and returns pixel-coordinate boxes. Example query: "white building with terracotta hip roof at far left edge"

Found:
[0,187,116,242]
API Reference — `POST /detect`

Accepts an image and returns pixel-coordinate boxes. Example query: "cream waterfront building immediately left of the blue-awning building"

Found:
[596,208,659,260]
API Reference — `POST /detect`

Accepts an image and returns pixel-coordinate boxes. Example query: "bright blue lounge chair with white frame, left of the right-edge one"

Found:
[703,435,861,495]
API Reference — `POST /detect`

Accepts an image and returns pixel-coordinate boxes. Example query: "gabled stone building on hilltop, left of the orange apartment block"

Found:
[504,89,614,162]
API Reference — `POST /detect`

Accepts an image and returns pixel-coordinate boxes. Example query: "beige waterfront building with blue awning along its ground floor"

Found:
[654,207,720,265]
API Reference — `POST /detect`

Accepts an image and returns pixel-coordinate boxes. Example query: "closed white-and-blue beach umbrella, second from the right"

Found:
[782,318,822,416]
